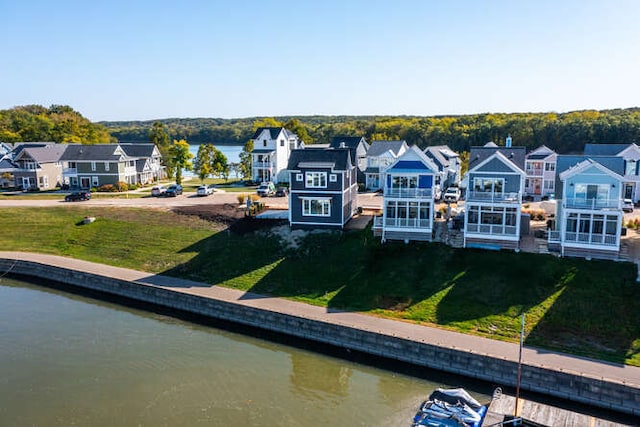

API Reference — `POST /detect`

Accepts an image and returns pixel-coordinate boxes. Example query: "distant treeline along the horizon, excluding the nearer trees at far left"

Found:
[100,108,640,153]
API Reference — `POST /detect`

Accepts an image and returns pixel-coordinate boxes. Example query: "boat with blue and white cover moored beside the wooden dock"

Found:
[413,388,487,427]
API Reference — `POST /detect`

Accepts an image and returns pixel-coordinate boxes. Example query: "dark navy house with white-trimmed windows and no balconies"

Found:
[287,148,358,229]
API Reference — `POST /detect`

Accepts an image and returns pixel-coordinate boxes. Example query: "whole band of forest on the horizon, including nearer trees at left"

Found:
[0,105,640,154]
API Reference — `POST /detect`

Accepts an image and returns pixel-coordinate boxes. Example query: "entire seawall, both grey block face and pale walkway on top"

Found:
[0,252,640,415]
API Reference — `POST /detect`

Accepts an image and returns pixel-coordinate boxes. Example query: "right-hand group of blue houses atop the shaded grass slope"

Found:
[286,132,640,259]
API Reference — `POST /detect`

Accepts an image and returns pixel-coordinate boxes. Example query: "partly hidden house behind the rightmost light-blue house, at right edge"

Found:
[584,143,640,202]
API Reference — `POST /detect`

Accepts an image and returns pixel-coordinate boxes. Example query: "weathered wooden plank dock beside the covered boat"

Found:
[482,393,625,427]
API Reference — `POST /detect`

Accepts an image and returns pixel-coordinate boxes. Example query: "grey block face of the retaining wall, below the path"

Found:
[0,259,640,415]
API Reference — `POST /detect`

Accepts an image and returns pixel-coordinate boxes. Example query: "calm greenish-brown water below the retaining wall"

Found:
[0,278,486,427]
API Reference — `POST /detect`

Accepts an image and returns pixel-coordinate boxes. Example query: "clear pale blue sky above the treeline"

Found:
[0,0,640,121]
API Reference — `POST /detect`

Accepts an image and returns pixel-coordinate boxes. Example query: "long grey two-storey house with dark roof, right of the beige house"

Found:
[60,144,139,189]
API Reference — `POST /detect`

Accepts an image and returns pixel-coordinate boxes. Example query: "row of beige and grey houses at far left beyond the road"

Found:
[0,142,166,190]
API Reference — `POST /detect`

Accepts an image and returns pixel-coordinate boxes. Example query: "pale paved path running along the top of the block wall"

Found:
[0,252,640,388]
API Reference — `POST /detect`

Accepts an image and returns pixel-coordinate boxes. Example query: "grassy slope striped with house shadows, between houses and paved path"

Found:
[0,206,640,366]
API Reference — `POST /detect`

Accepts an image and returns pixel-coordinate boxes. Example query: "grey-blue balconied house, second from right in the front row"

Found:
[464,140,525,249]
